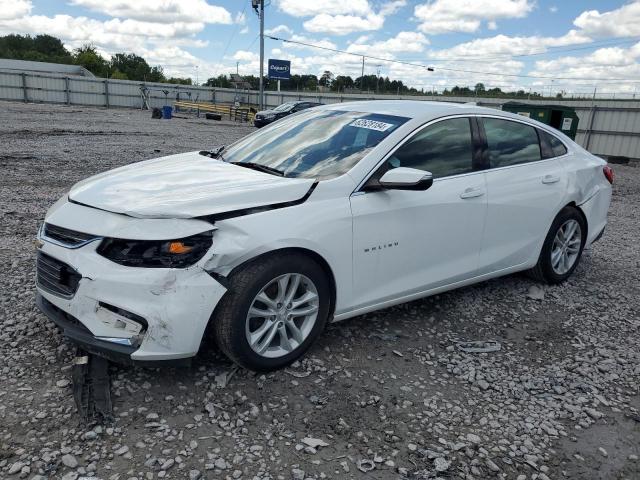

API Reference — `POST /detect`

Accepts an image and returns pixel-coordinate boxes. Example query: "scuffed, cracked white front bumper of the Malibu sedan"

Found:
[37,241,226,363]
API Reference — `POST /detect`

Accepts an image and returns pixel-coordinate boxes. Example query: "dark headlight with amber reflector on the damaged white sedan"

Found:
[97,232,213,268]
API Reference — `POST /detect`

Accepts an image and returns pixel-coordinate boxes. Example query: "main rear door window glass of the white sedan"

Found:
[482,118,542,168]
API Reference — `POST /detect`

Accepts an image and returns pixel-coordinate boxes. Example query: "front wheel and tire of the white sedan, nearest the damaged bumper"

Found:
[213,253,331,371]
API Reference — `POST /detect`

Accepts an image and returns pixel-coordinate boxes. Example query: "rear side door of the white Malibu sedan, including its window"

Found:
[479,117,568,274]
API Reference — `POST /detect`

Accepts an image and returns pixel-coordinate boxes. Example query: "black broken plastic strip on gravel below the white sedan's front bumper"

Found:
[72,349,114,423]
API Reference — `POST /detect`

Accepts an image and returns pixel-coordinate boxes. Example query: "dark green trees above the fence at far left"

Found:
[0,34,191,85]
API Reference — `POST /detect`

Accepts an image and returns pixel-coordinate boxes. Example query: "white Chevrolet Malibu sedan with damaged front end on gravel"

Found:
[37,101,613,371]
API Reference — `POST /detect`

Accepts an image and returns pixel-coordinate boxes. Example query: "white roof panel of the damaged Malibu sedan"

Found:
[320,100,520,123]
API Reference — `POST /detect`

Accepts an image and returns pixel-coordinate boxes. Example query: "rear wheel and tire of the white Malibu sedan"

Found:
[527,207,587,284]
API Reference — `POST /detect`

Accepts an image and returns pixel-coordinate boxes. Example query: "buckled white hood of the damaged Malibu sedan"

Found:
[69,152,314,218]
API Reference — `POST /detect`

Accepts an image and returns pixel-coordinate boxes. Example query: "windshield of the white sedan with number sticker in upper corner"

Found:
[224,110,408,179]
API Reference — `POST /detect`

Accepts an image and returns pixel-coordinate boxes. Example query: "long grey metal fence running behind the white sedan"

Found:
[0,70,640,159]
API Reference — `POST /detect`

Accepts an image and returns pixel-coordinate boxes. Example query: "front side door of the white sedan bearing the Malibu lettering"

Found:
[351,117,487,308]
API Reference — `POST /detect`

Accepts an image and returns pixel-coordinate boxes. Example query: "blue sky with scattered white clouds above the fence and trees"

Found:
[0,0,640,95]
